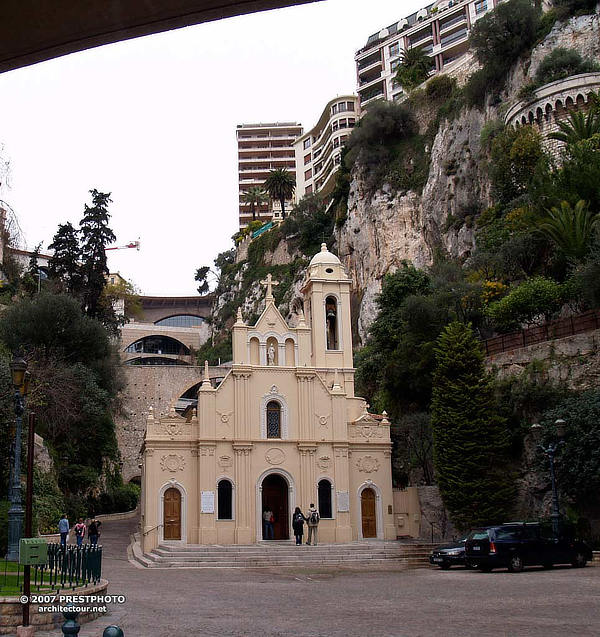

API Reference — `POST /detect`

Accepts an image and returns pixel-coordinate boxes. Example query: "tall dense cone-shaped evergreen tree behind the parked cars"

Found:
[431,322,514,531]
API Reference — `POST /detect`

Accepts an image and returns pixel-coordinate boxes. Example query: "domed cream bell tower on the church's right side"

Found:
[302,243,352,369]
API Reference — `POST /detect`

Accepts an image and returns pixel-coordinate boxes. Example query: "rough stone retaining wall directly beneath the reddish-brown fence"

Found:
[486,330,600,390]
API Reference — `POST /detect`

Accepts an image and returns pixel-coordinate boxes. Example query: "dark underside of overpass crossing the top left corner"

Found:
[0,0,320,72]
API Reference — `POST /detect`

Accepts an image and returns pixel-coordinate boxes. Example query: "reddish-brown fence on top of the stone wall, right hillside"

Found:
[483,310,600,356]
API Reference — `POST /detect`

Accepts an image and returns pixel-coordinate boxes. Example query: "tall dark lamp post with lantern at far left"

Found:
[7,357,29,560]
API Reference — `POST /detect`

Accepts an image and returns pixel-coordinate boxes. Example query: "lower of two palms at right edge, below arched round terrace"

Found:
[538,200,600,263]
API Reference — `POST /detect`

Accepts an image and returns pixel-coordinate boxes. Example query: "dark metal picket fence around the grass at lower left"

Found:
[0,543,102,596]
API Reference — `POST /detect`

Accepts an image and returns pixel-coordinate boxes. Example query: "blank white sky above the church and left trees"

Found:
[0,0,425,295]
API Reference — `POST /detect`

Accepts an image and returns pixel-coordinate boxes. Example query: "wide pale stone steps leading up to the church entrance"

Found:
[136,541,433,569]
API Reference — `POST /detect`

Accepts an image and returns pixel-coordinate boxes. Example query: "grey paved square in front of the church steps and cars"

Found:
[38,520,600,637]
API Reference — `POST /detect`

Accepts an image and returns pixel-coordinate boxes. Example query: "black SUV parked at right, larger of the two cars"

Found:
[465,522,592,573]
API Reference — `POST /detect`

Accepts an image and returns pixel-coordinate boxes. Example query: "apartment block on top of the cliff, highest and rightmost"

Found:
[354,0,501,108]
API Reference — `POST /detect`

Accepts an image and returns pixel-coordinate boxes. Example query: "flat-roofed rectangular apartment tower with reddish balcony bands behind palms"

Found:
[236,122,303,228]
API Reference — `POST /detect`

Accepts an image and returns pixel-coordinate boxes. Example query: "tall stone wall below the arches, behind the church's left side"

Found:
[115,365,227,482]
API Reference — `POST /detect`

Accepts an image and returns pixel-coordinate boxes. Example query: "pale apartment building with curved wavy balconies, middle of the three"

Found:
[294,95,359,201]
